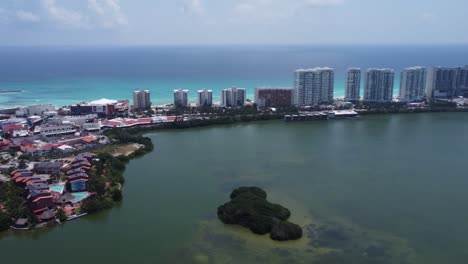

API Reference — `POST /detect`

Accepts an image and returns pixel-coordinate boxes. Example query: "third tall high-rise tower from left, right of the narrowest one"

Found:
[364,68,395,102]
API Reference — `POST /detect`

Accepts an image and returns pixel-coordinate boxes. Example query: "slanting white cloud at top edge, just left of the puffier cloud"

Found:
[41,0,89,28]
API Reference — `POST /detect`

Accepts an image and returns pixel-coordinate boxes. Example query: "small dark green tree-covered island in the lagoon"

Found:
[218,187,302,241]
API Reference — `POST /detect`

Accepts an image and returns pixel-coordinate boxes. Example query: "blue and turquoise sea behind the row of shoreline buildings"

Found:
[0,45,468,107]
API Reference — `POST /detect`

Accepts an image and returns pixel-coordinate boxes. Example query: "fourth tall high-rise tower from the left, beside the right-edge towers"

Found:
[400,66,427,102]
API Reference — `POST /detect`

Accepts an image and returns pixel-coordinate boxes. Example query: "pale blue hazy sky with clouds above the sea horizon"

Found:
[0,0,468,46]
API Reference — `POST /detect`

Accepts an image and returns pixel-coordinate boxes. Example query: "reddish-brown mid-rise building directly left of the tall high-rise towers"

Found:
[255,87,293,109]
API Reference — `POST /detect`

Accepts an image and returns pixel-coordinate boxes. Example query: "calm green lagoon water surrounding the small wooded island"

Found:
[0,113,468,264]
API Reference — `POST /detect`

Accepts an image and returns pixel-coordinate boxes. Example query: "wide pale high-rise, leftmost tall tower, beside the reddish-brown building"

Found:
[294,68,335,106]
